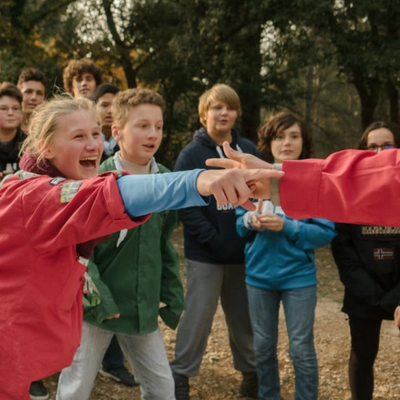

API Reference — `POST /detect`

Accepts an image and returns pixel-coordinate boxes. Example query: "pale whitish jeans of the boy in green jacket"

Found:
[56,321,175,400]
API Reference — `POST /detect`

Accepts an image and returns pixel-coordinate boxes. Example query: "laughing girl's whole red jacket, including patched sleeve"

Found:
[0,173,148,400]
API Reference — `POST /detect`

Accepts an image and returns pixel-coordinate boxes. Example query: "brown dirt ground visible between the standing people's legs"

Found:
[46,245,400,400]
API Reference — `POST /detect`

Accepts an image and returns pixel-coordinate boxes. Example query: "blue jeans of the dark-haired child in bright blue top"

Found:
[247,285,318,400]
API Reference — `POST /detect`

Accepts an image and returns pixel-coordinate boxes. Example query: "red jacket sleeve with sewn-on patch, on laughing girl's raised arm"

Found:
[8,173,148,253]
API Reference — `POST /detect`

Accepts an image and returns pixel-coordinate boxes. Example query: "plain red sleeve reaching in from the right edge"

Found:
[279,149,400,226]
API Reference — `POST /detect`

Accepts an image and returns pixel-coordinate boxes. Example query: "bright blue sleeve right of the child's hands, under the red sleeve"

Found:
[282,218,336,250]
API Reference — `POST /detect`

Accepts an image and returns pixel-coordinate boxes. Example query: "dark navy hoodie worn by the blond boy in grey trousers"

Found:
[174,128,259,264]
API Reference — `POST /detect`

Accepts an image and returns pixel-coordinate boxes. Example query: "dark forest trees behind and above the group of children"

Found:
[0,0,400,167]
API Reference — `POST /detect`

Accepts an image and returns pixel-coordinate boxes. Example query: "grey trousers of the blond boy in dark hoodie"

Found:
[171,260,256,377]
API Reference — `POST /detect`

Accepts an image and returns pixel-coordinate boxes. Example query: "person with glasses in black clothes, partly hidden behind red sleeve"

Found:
[332,122,400,400]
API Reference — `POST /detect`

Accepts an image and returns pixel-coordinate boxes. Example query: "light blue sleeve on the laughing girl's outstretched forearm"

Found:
[117,169,207,217]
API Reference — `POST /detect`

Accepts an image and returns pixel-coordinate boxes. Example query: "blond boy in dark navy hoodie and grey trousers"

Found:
[171,85,258,400]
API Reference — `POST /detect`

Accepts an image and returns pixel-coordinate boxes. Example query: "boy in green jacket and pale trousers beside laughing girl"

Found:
[57,88,184,400]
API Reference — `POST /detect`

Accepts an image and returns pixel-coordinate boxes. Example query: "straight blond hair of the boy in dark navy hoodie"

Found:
[199,84,242,126]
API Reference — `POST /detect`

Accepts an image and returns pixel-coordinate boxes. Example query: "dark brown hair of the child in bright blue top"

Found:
[258,111,312,163]
